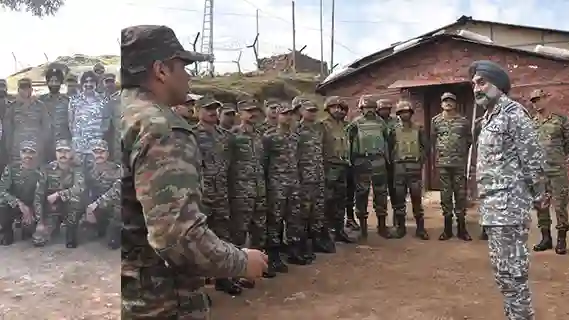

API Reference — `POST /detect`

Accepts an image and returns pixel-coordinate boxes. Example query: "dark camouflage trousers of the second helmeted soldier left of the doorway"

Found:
[353,161,388,219]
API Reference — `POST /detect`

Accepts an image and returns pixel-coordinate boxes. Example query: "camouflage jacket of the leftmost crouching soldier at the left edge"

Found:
[0,164,44,217]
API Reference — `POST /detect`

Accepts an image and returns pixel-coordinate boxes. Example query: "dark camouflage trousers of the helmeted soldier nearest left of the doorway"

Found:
[391,163,425,218]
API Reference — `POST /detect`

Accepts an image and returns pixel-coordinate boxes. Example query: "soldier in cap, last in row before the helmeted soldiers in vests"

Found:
[297,100,335,260]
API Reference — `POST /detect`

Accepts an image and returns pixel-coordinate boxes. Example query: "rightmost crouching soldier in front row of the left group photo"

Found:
[85,140,122,250]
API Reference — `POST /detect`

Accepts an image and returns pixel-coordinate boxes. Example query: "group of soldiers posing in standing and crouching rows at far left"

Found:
[0,63,122,249]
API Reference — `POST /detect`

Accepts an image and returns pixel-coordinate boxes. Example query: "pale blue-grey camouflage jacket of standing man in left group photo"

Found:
[68,93,112,154]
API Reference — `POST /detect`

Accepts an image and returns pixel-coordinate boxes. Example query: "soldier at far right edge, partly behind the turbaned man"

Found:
[530,90,569,254]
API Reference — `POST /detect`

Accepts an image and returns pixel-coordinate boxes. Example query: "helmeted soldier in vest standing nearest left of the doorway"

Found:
[391,101,429,240]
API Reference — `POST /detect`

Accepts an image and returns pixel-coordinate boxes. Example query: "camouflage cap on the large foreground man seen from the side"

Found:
[121,25,213,74]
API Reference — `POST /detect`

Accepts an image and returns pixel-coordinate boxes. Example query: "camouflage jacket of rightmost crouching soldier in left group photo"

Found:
[85,161,123,209]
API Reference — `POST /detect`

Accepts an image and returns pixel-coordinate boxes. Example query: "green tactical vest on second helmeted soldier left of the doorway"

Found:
[353,119,386,157]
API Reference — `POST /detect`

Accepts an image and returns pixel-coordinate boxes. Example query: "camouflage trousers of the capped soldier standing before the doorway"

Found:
[439,167,467,217]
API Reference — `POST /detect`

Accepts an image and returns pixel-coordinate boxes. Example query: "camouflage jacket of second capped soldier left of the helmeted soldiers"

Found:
[263,127,299,184]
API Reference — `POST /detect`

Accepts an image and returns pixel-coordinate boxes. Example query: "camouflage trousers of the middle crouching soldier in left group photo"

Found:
[32,201,81,244]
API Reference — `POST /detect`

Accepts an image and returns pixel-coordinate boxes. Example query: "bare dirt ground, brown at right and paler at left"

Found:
[0,195,569,320]
